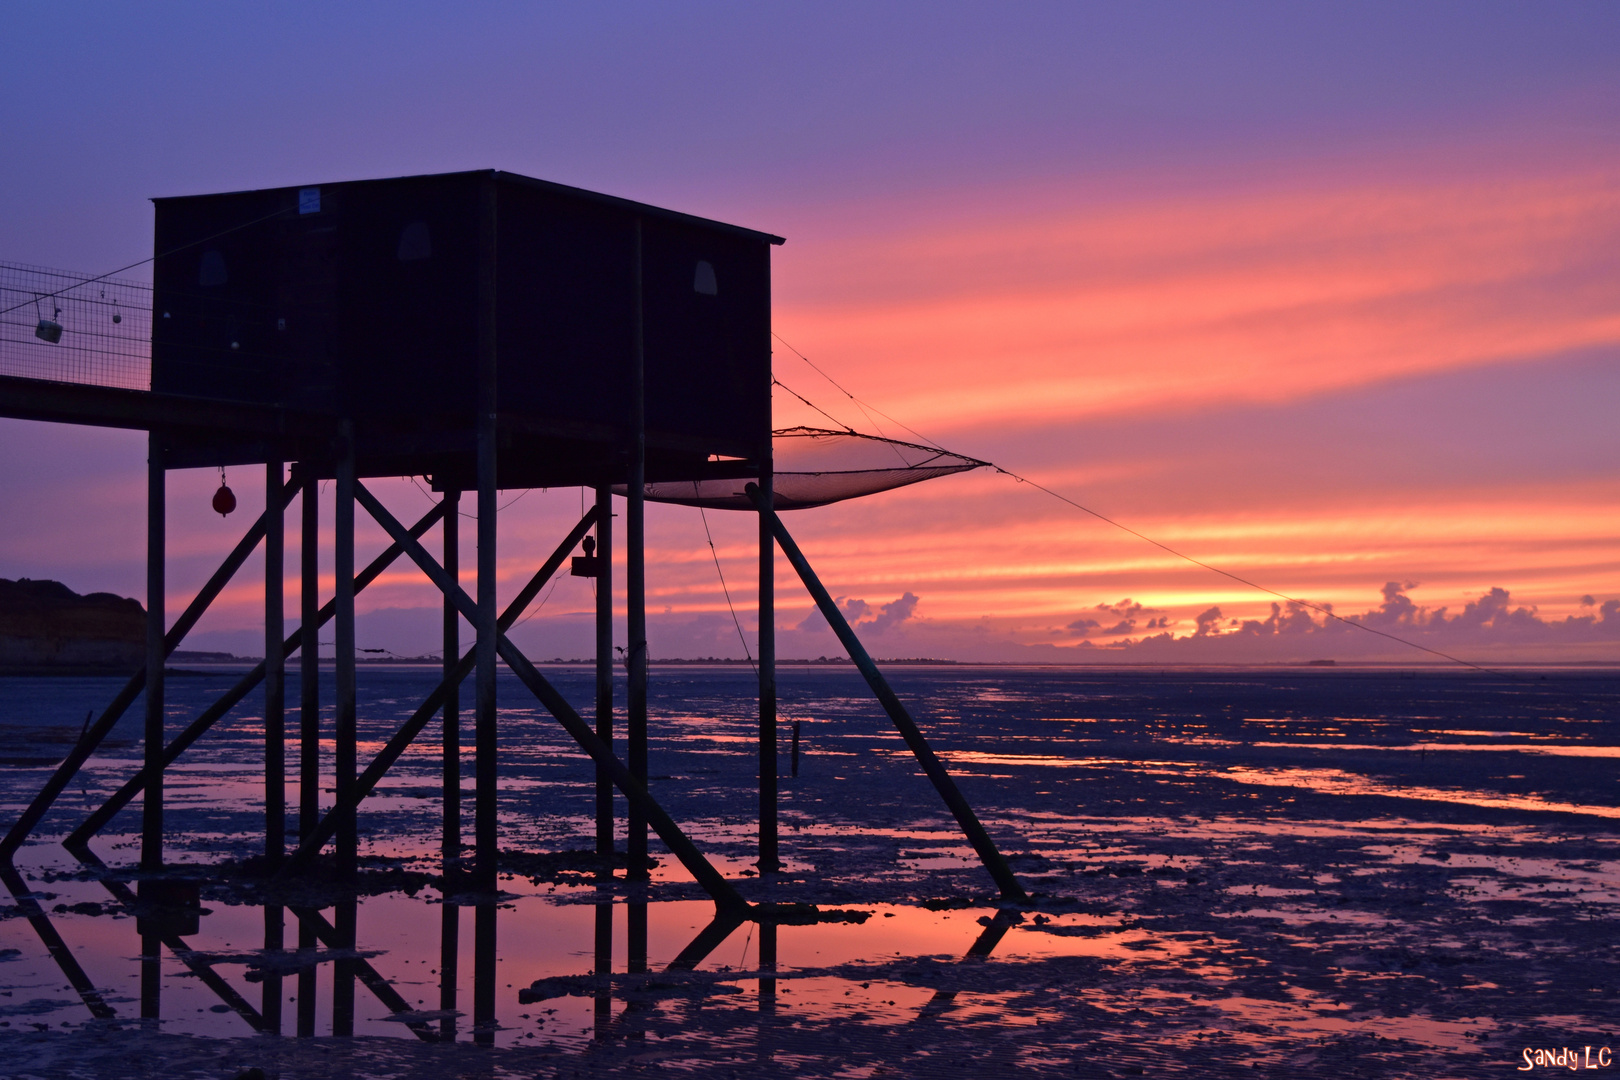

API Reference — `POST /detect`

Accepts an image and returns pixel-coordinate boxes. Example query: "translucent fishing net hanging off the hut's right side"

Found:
[628,427,990,510]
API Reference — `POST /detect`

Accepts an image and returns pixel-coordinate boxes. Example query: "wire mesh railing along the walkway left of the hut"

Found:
[0,262,152,390]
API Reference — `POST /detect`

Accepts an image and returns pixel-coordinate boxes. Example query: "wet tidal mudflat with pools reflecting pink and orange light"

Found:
[0,665,1620,1080]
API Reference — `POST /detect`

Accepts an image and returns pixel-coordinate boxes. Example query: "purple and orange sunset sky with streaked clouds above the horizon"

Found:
[0,0,1620,664]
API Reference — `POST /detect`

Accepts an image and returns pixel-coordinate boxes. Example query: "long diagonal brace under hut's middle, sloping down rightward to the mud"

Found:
[355,481,748,910]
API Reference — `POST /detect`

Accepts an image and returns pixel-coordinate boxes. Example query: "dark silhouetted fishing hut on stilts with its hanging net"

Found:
[0,172,1024,1030]
